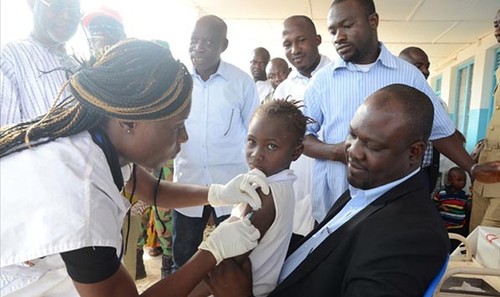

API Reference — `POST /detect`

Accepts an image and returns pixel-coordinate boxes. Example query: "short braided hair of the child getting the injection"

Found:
[253,98,314,144]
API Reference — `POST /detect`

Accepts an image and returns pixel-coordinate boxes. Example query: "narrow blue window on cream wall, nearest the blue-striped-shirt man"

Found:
[454,62,474,137]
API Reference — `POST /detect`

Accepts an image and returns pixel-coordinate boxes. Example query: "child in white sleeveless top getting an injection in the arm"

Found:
[190,99,312,296]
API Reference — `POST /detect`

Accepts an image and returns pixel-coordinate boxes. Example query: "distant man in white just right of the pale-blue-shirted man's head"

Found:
[250,47,273,102]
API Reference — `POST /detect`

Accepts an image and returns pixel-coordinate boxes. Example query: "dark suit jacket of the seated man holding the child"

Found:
[269,173,449,297]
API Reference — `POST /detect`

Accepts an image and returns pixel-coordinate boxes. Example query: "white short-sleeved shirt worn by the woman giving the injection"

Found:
[0,132,130,296]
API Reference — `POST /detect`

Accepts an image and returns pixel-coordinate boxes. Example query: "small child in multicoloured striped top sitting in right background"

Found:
[434,167,471,251]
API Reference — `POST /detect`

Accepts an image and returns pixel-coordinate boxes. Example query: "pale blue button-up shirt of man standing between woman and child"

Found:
[174,61,259,217]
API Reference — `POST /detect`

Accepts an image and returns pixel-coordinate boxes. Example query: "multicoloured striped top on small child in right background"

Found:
[433,186,471,230]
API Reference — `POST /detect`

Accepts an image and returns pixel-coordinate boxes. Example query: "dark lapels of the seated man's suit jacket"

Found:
[277,173,423,291]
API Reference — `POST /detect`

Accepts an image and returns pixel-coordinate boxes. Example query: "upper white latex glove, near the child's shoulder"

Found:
[208,169,269,210]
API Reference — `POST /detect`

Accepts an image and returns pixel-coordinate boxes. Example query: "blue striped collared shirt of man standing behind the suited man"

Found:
[304,43,455,222]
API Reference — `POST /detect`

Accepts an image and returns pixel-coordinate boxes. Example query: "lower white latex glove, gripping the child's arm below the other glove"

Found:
[198,218,260,265]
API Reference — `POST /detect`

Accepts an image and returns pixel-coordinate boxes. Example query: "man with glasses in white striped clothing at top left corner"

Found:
[0,0,81,126]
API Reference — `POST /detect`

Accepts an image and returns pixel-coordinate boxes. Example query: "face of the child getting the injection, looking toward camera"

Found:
[245,116,303,176]
